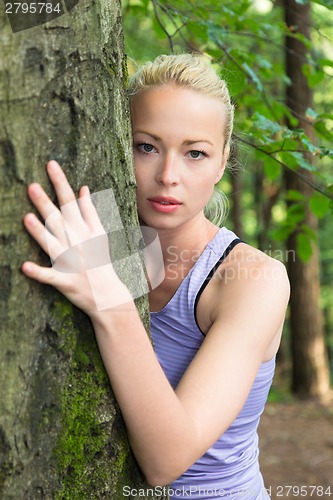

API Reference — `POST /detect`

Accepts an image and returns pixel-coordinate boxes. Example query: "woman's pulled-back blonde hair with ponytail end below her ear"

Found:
[128,54,234,226]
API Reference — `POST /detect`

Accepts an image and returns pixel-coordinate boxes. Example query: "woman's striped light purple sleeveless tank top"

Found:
[150,228,275,500]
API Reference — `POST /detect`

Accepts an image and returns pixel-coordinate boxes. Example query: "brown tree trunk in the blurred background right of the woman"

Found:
[284,0,329,398]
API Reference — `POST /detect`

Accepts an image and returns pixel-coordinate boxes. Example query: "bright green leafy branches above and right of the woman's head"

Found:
[124,0,333,254]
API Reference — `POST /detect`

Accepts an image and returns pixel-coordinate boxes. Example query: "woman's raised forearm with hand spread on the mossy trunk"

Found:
[22,161,195,484]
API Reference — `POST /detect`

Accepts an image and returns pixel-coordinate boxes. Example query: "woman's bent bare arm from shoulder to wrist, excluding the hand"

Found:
[93,254,289,485]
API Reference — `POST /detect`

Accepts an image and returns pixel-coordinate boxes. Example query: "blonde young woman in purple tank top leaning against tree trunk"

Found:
[22,54,289,500]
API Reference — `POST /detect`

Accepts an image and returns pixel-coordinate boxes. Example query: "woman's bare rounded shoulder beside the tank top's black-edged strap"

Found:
[197,242,290,332]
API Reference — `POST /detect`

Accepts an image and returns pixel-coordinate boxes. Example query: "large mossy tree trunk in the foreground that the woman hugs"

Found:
[0,0,166,500]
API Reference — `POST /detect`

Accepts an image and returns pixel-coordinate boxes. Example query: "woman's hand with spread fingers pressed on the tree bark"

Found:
[21,161,132,317]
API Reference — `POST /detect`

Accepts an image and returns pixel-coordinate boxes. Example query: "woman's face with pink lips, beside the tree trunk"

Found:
[132,85,227,230]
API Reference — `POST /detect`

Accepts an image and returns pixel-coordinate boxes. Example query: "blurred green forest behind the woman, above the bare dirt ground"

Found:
[123,0,333,401]
